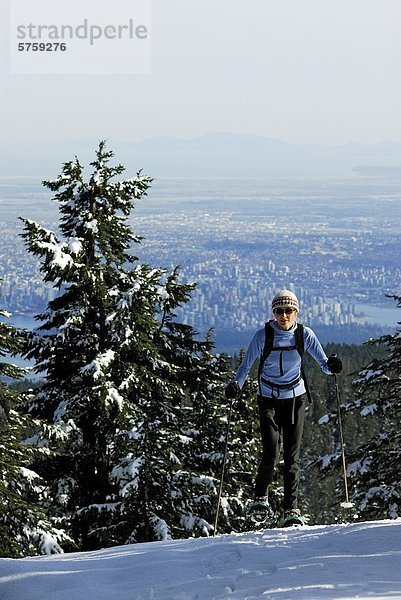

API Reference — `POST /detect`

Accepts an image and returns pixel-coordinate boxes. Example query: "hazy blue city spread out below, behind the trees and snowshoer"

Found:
[0,177,401,350]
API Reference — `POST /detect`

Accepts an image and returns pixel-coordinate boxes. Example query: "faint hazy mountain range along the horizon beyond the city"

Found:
[0,133,401,179]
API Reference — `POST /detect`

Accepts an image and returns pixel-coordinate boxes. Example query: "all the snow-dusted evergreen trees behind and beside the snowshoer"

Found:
[0,142,401,557]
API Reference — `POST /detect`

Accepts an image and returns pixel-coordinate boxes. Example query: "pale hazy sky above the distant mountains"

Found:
[0,0,401,144]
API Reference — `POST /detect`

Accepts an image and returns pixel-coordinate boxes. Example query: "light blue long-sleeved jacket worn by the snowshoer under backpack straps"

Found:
[235,321,330,398]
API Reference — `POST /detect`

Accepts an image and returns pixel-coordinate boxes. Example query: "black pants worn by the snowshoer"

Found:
[255,394,306,510]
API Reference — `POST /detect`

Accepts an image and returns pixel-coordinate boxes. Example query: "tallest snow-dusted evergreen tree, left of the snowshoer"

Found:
[23,142,234,549]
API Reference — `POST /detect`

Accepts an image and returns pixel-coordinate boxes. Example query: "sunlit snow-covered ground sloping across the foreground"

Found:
[0,519,401,600]
